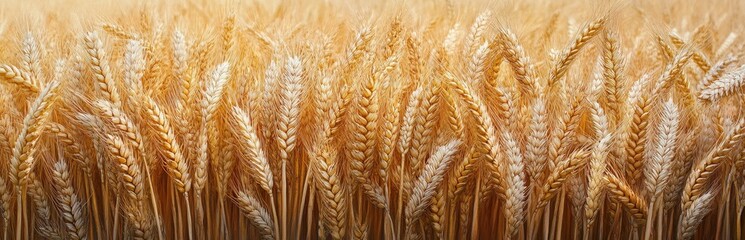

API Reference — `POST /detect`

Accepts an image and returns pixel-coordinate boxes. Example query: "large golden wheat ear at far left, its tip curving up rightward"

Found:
[8,82,59,188]
